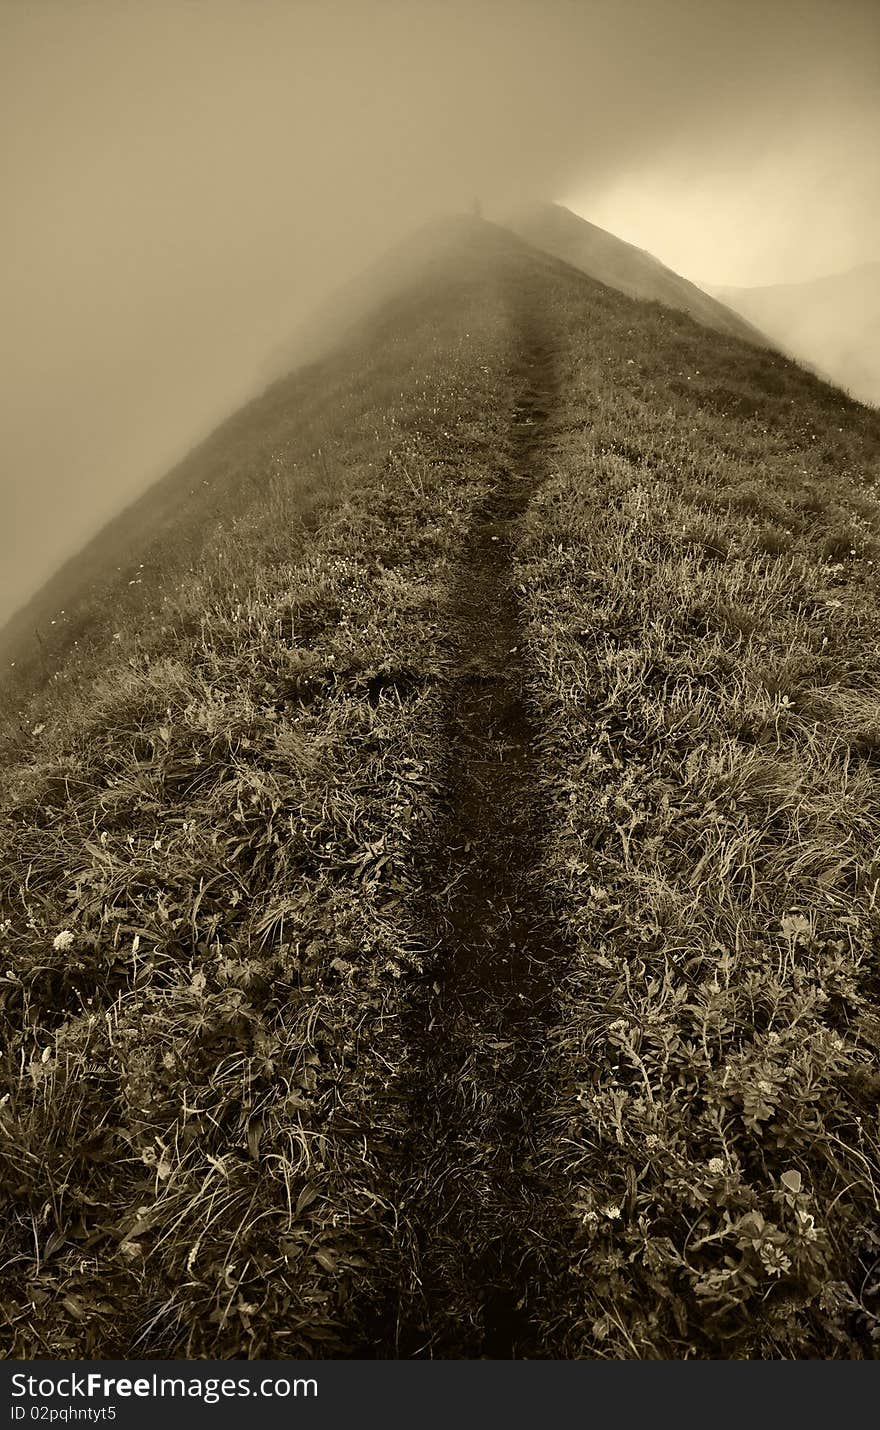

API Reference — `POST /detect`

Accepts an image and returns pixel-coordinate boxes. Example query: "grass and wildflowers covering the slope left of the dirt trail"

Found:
[0,268,504,1356]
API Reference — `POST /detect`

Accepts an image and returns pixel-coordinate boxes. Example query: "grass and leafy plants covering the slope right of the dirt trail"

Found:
[519,265,880,1357]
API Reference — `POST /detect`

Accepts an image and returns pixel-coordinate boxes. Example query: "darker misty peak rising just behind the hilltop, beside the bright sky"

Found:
[505,203,766,343]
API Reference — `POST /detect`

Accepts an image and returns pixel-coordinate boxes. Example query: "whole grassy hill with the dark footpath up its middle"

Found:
[0,223,880,1359]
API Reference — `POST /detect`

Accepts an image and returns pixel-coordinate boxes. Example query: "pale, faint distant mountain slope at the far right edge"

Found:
[707,263,880,406]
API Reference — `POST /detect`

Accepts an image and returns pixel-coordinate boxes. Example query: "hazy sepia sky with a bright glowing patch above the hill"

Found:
[0,0,880,619]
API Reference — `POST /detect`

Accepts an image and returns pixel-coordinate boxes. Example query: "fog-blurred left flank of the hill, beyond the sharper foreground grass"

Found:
[0,236,509,762]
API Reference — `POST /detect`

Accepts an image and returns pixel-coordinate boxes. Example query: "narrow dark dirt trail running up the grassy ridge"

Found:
[363,298,567,1359]
